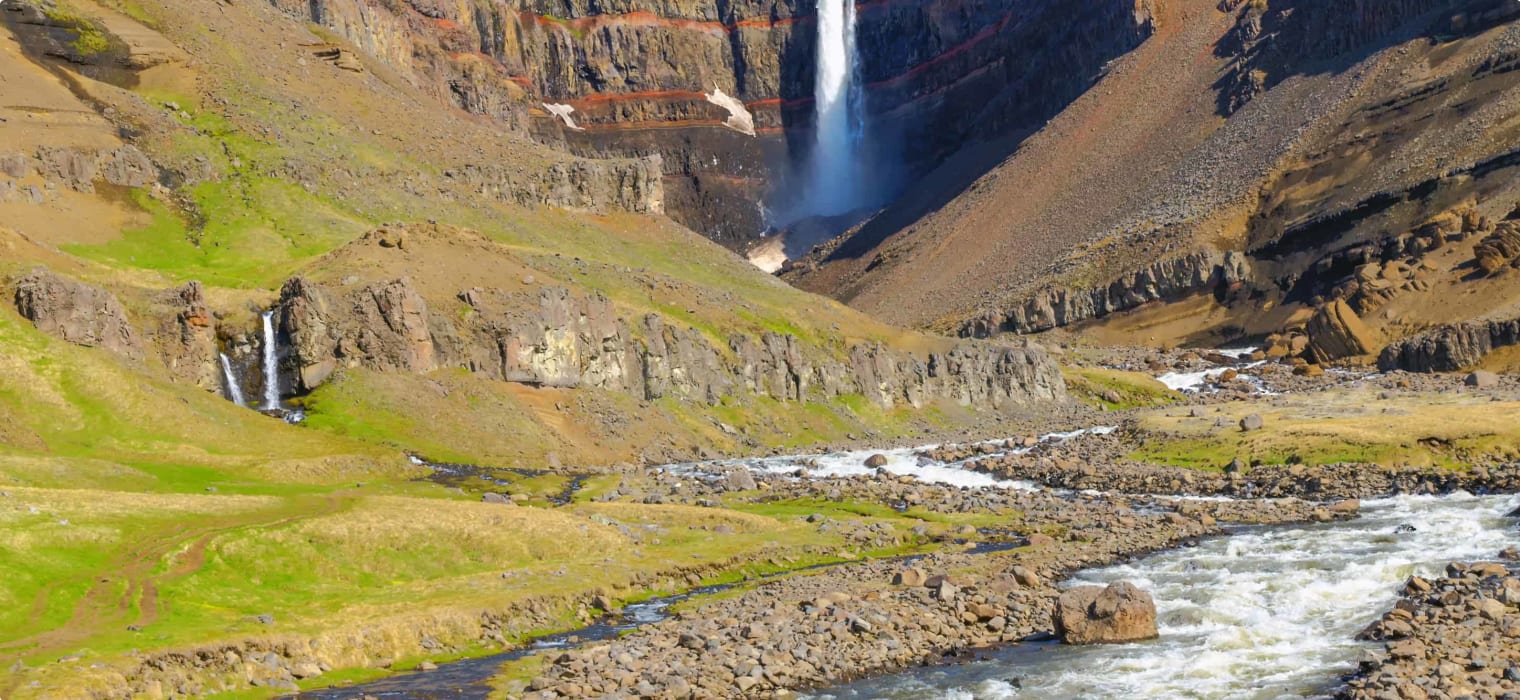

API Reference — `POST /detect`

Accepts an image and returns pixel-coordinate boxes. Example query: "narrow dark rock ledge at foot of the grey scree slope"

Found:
[961,251,1251,337]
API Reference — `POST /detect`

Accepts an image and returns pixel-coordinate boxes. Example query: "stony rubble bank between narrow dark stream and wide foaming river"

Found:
[495,477,1354,698]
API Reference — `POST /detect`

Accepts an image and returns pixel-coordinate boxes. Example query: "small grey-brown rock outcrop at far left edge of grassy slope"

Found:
[15,269,143,360]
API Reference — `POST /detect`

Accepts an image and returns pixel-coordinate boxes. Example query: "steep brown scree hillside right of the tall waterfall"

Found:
[789,0,1520,358]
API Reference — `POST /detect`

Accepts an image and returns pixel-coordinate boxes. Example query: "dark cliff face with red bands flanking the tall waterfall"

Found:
[271,0,1151,248]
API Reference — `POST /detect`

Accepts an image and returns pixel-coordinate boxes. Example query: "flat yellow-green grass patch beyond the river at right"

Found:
[1131,387,1520,469]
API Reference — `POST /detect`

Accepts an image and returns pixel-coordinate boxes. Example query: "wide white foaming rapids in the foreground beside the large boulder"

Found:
[819,495,1520,700]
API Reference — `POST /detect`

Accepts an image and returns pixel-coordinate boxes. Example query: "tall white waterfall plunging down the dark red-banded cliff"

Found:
[806,0,863,216]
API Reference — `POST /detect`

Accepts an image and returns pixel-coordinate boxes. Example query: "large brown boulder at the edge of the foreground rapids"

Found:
[1053,582,1157,644]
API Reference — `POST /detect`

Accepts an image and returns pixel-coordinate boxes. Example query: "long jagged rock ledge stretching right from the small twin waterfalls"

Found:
[278,271,1066,408]
